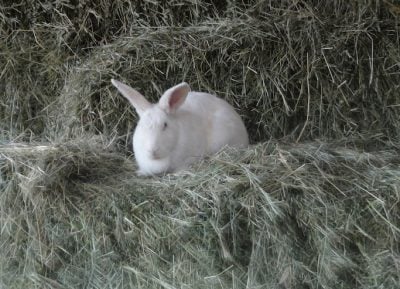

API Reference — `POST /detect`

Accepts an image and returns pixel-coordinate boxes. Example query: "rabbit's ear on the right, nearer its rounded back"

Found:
[159,82,190,113]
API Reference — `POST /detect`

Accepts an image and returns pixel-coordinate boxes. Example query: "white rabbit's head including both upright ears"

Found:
[111,79,190,161]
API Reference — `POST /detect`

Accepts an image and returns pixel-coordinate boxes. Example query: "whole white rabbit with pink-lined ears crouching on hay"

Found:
[111,79,249,175]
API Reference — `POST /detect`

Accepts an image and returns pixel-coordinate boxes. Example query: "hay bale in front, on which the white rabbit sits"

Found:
[0,139,400,288]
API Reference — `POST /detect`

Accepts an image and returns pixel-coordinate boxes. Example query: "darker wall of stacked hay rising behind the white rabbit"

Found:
[0,0,400,141]
